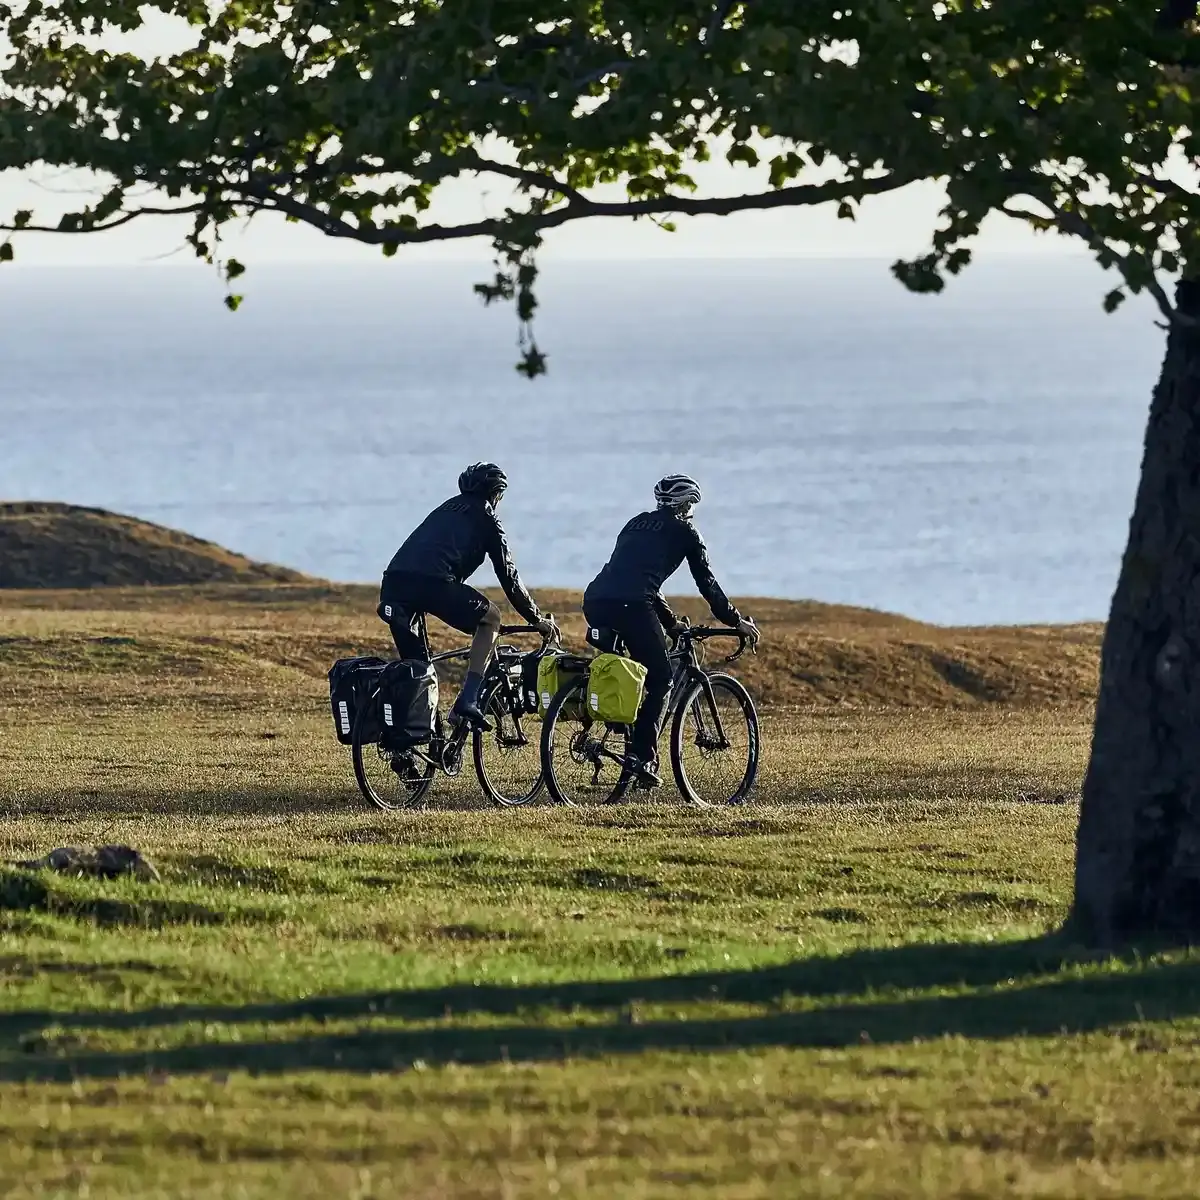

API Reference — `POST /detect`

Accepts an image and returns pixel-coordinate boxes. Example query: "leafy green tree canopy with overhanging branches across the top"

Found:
[0,0,1200,376]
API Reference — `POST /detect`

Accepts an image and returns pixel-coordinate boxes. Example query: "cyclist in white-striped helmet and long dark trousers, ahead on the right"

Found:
[583,475,758,787]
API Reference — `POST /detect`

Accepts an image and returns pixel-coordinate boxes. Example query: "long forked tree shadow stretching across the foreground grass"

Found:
[0,937,1200,1081]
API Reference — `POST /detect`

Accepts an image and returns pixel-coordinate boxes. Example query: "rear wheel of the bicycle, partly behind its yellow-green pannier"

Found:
[541,682,632,805]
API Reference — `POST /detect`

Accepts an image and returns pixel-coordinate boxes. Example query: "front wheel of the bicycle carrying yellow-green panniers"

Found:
[671,674,760,809]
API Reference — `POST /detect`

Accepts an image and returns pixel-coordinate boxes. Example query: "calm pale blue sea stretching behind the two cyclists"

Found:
[0,258,1163,623]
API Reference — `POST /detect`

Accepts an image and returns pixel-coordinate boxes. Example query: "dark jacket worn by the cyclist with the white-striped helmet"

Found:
[583,509,742,629]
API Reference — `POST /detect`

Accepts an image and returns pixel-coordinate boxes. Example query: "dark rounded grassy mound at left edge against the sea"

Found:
[0,503,304,588]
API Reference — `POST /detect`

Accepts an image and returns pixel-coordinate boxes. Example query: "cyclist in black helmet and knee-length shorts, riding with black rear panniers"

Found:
[378,462,558,730]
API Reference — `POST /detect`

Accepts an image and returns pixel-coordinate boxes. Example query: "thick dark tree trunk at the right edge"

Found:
[1073,282,1200,944]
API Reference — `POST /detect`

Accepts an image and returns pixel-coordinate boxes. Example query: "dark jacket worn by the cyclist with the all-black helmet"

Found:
[384,496,541,624]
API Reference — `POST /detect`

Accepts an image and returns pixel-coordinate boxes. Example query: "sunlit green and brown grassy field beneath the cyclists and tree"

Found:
[0,587,1200,1200]
